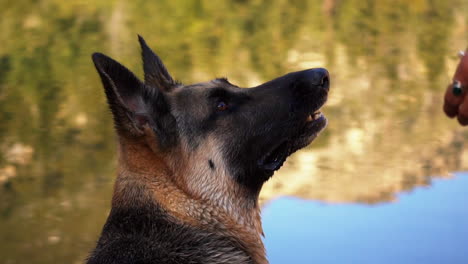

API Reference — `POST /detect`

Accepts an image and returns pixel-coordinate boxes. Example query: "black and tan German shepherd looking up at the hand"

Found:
[87,36,329,264]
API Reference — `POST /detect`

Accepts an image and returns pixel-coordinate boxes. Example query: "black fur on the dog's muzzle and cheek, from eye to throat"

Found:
[212,69,328,191]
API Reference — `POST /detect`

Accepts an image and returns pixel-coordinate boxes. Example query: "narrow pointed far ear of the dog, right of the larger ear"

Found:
[138,35,176,92]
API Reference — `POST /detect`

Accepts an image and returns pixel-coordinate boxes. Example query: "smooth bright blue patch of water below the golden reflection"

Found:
[263,172,468,264]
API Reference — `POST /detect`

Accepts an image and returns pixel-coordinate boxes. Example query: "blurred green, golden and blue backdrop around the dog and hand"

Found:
[0,0,468,264]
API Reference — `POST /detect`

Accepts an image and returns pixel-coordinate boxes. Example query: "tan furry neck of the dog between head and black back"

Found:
[112,137,267,263]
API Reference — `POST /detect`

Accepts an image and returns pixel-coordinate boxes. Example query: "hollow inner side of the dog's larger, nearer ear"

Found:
[92,53,158,136]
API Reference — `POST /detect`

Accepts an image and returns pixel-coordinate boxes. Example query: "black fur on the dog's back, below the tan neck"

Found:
[87,185,252,264]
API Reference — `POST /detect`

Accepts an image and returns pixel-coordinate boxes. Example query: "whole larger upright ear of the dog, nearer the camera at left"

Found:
[92,53,175,145]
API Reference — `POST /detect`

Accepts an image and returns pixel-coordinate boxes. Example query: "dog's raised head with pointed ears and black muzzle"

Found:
[93,37,329,198]
